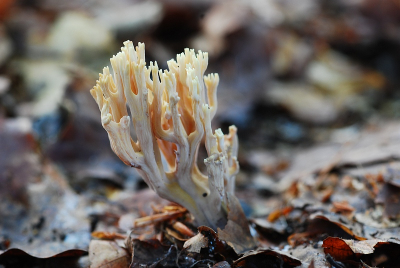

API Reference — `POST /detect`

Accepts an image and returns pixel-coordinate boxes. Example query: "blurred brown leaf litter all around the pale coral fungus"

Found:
[0,0,400,267]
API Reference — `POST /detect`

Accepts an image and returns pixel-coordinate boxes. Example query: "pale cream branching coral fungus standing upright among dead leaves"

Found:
[90,41,241,230]
